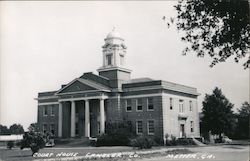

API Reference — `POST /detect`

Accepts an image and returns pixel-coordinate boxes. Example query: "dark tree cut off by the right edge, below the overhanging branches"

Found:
[236,102,250,139]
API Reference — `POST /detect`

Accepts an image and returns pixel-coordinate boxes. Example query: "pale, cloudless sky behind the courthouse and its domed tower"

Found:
[0,1,249,129]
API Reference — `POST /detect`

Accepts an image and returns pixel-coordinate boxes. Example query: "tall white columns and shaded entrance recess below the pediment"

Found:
[58,99,106,138]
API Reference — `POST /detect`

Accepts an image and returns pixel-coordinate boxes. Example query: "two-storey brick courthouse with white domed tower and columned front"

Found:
[37,31,200,138]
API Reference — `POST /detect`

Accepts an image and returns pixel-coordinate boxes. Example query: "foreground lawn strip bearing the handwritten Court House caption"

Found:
[0,147,192,161]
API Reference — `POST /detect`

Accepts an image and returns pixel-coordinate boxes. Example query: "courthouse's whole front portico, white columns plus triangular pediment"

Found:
[53,78,110,138]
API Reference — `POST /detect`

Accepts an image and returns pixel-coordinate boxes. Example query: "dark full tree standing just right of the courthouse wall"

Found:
[201,87,235,136]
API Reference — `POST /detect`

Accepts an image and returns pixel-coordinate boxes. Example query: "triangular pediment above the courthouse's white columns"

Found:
[58,80,98,94]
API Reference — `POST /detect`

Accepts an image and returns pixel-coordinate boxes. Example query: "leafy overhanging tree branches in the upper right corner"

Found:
[163,0,250,68]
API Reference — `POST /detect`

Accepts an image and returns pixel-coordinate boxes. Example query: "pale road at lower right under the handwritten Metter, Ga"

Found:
[136,145,250,161]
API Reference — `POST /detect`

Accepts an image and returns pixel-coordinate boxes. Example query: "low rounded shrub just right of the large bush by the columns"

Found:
[130,135,154,149]
